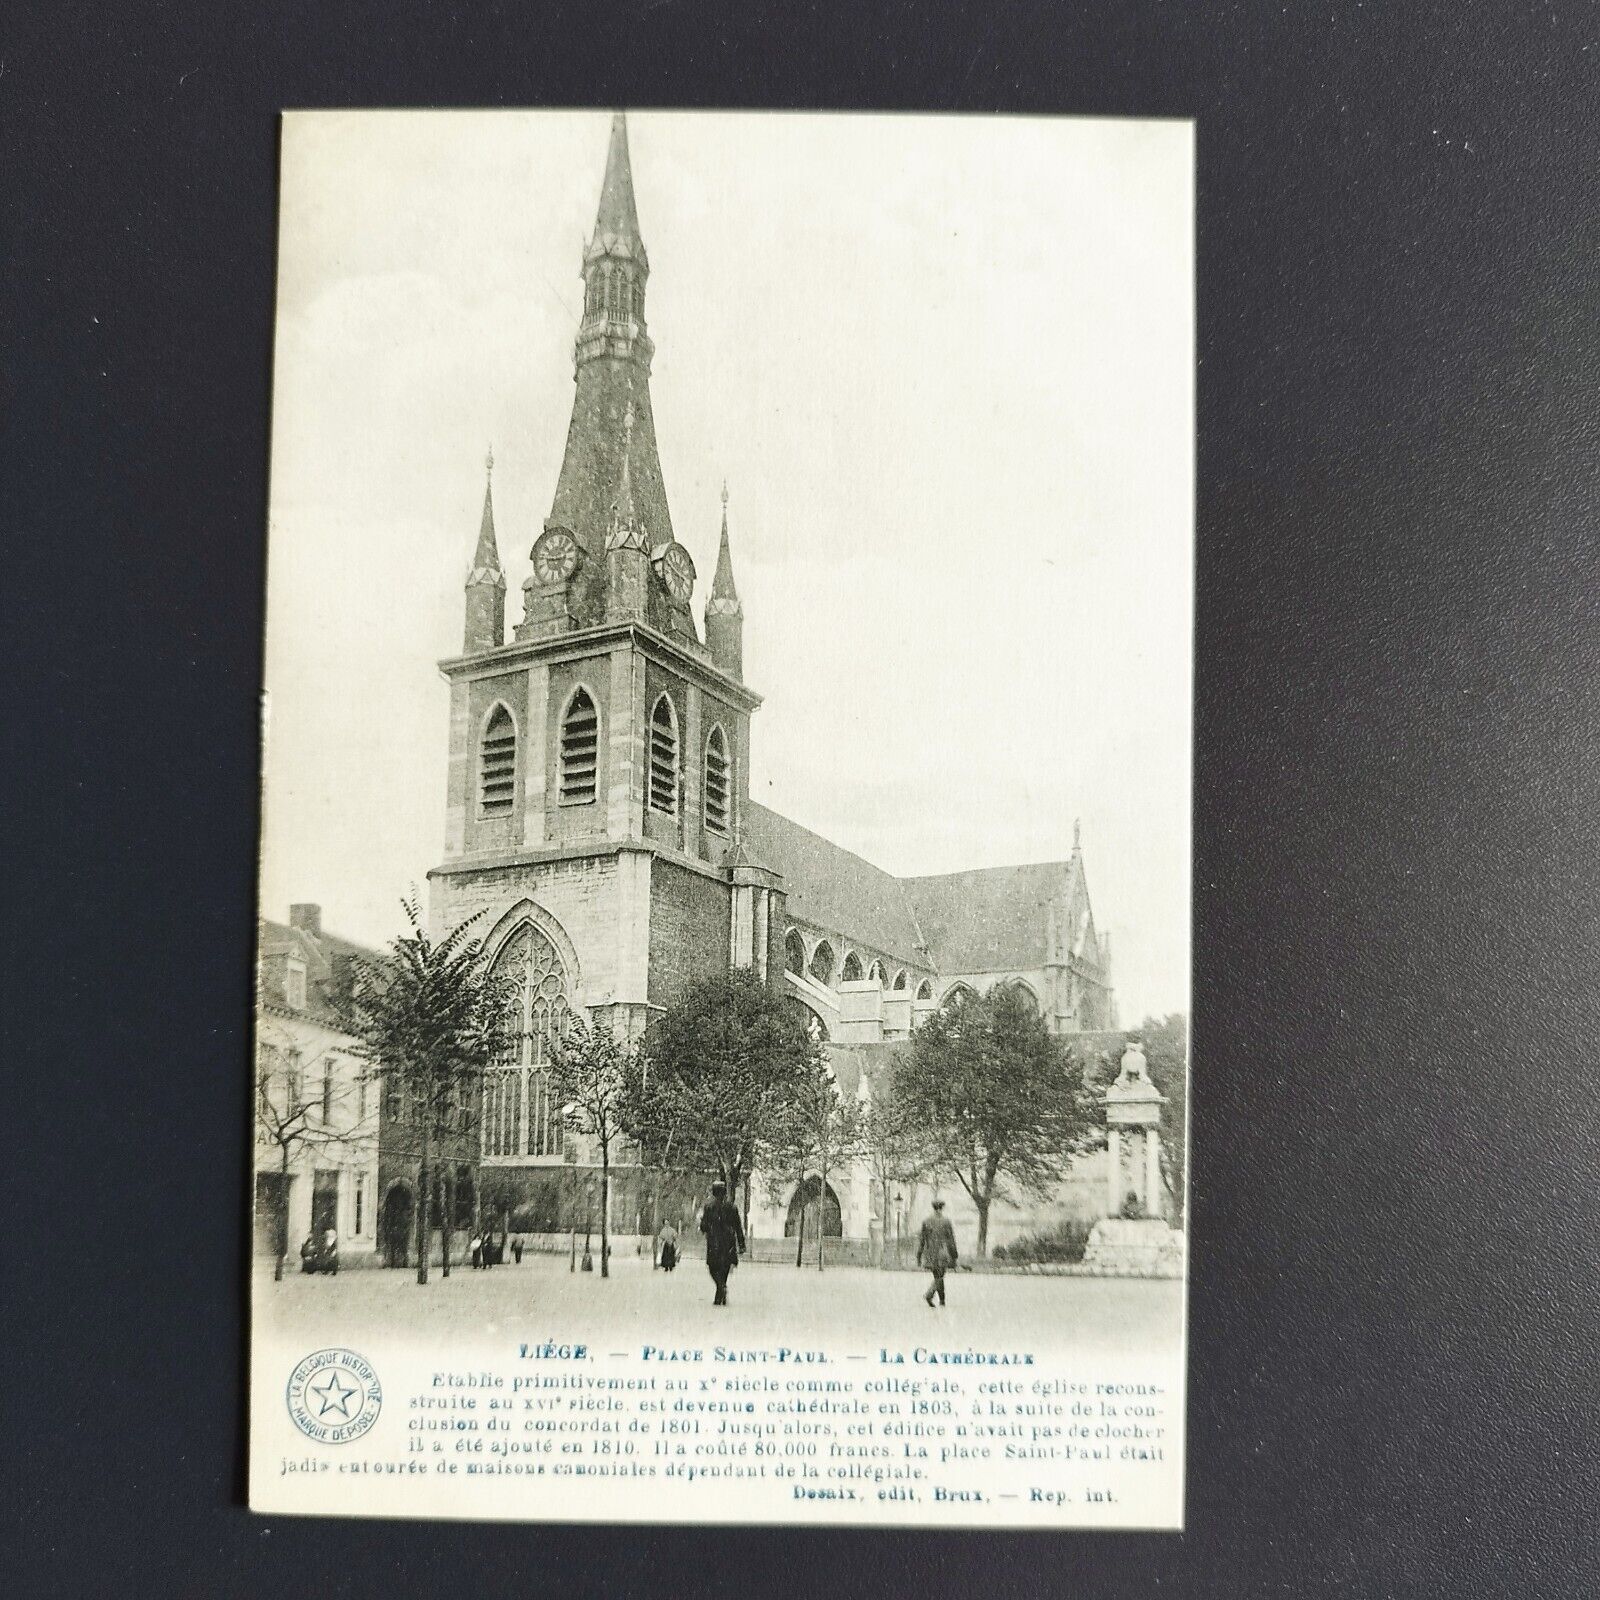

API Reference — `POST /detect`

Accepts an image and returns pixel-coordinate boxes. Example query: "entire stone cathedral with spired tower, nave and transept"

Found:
[406,115,1115,1260]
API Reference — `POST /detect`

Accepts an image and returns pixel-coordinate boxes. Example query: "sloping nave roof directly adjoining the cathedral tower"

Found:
[746,800,931,970]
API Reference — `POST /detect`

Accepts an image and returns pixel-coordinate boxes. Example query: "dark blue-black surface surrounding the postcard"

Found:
[0,0,1600,1597]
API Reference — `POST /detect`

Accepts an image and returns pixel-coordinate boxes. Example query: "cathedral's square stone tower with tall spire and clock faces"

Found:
[429,115,782,1182]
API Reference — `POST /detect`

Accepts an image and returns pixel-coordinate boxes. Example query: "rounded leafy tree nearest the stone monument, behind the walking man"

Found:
[894,986,1101,1256]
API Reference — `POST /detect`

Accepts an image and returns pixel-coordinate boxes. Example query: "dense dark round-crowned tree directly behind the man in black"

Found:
[624,968,819,1213]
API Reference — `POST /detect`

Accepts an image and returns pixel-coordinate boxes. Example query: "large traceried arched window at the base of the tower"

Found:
[483,923,570,1157]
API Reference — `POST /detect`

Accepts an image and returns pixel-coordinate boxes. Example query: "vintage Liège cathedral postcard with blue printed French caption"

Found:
[250,110,1205,1528]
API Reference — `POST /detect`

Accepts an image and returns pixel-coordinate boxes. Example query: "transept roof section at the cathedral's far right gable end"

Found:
[904,859,1094,974]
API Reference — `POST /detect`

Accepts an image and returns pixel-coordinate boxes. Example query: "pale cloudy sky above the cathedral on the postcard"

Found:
[262,112,1194,1022]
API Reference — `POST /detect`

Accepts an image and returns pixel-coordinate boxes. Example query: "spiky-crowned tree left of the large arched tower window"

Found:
[342,898,510,1283]
